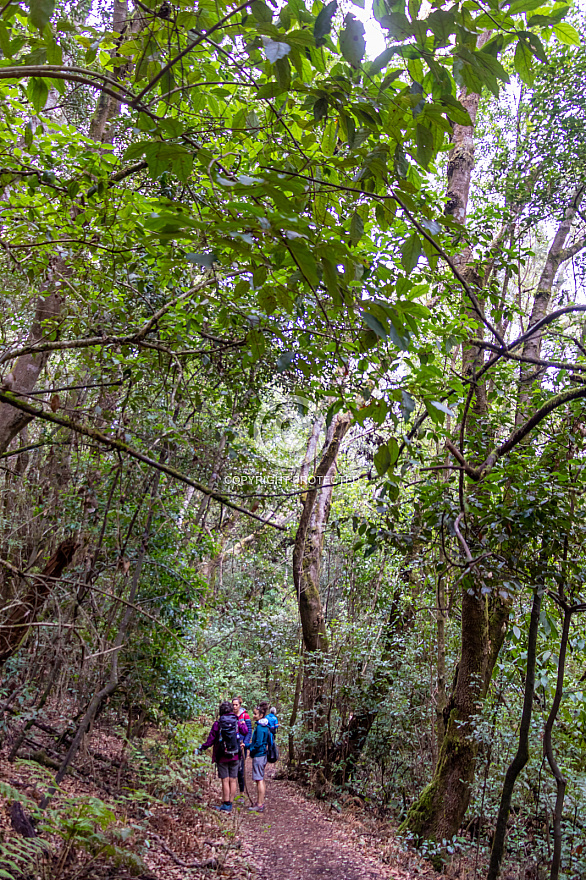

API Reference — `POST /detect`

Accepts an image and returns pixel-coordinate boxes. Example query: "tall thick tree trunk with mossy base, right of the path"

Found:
[401,32,502,841]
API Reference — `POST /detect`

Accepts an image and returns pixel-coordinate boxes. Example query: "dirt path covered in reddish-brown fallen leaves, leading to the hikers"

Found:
[240,761,405,880]
